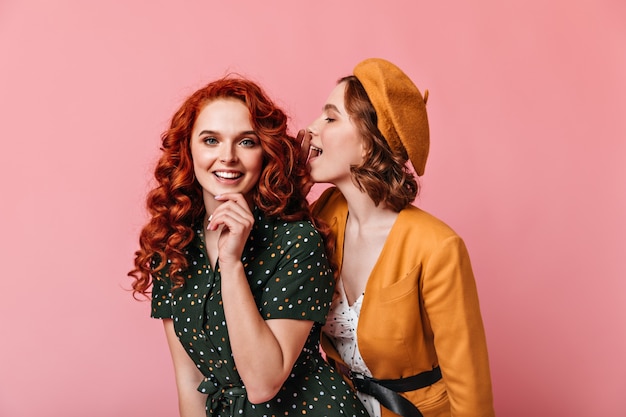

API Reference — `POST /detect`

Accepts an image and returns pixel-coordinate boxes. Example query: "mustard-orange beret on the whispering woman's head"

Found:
[354,58,430,175]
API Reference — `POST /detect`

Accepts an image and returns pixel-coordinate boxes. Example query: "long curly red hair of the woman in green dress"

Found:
[128,74,334,297]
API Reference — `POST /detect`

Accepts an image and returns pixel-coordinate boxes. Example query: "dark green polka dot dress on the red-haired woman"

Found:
[151,211,367,417]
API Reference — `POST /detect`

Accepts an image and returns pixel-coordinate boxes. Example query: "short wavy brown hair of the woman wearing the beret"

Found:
[338,75,419,212]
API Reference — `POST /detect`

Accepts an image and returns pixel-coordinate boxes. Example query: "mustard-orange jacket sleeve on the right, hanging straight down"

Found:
[422,235,494,417]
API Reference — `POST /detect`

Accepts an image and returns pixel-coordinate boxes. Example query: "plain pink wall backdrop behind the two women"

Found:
[0,0,626,417]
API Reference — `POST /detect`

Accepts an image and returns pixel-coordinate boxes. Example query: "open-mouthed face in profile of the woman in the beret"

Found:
[309,83,364,185]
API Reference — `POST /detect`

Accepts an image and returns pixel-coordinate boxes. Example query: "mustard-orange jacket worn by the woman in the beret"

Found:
[314,188,494,417]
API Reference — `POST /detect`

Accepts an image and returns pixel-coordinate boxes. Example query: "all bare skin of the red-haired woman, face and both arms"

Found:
[164,99,313,417]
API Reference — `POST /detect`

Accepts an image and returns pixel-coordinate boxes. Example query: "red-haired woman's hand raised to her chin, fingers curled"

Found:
[207,193,254,265]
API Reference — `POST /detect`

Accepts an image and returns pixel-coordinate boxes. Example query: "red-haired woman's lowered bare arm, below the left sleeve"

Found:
[163,319,207,417]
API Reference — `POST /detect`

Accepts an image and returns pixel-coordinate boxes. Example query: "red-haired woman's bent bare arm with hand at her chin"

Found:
[208,194,313,403]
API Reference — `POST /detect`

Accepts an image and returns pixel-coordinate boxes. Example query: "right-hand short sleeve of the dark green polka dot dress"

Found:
[259,222,334,323]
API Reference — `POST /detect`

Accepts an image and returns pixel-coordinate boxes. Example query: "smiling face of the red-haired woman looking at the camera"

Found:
[190,98,263,202]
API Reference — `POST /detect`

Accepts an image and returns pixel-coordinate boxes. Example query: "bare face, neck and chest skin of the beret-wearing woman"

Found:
[303,83,398,305]
